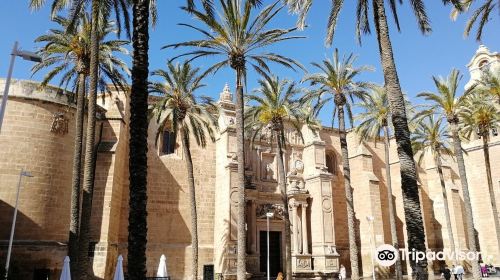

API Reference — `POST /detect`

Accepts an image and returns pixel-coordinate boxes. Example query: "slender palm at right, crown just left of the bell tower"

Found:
[417,69,481,280]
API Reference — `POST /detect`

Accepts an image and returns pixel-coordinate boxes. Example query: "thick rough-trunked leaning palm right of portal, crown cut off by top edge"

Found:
[283,0,434,280]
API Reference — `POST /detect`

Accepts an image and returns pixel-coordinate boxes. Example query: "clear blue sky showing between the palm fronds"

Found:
[0,0,500,123]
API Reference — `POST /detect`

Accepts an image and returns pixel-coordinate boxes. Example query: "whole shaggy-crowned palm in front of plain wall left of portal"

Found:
[149,62,218,279]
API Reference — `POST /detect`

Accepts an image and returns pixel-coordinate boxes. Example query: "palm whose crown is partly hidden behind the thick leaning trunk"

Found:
[355,86,403,280]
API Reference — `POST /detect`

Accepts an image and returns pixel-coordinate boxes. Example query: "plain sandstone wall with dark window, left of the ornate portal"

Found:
[117,91,216,280]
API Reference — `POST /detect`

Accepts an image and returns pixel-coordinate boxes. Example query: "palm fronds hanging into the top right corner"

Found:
[443,0,500,41]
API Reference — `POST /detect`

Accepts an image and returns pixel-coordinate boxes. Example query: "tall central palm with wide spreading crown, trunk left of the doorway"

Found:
[164,0,302,280]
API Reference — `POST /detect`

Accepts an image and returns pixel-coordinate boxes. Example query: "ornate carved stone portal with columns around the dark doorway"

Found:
[214,87,339,279]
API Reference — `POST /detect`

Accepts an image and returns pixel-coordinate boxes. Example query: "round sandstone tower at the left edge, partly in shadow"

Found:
[0,80,75,279]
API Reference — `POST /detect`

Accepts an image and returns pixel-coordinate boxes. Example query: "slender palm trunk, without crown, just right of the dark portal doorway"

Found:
[275,127,297,280]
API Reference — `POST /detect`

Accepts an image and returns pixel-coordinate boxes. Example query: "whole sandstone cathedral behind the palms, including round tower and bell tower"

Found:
[0,46,500,279]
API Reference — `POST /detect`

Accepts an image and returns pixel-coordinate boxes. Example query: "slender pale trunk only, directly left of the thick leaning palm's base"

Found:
[384,125,403,280]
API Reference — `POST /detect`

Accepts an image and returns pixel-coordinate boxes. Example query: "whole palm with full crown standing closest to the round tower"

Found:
[32,13,129,277]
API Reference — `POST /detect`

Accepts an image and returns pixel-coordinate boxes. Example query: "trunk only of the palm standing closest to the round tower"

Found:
[68,73,86,279]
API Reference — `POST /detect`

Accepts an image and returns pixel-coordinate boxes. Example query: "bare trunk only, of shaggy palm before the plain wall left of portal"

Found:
[180,128,198,280]
